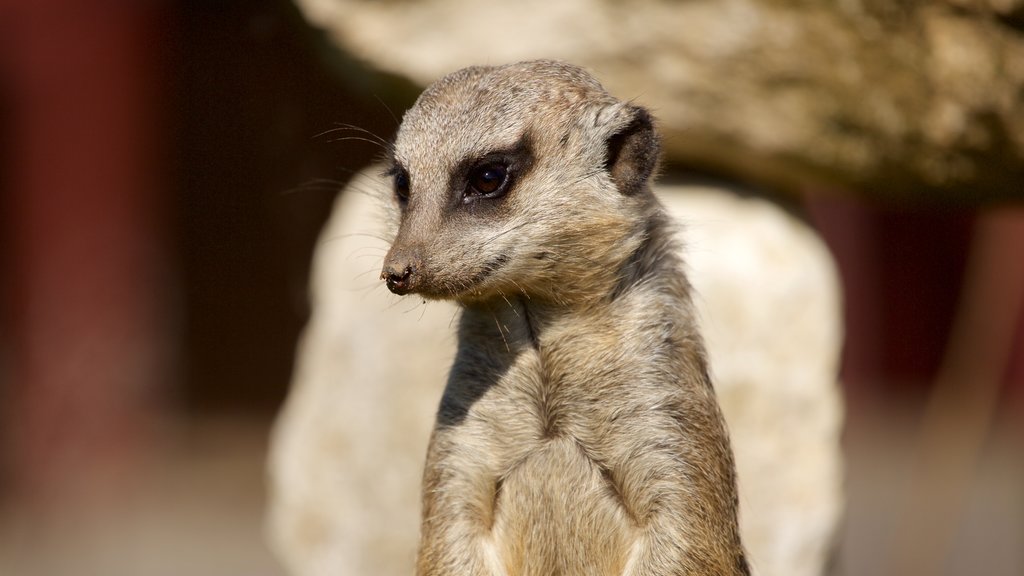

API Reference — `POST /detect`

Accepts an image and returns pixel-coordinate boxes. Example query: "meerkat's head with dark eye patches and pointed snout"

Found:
[381,60,658,304]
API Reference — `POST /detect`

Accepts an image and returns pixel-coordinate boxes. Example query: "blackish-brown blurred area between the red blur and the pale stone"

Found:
[168,0,395,413]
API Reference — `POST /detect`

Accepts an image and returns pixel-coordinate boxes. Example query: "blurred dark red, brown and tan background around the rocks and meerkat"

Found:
[0,0,1024,575]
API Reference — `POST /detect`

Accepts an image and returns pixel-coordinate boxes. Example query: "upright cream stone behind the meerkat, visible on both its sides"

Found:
[268,169,842,576]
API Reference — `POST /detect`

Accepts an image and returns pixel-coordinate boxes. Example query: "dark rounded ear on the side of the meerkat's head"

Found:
[604,106,660,196]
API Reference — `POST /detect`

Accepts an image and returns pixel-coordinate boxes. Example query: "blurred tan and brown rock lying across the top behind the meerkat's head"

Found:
[297,0,1024,202]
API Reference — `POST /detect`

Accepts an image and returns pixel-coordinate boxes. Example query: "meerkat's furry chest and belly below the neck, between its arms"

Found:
[434,303,684,575]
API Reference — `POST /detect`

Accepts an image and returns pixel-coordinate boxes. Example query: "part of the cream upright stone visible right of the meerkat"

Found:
[662,187,843,576]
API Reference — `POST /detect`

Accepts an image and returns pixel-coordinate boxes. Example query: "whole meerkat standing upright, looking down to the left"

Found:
[381,60,749,576]
